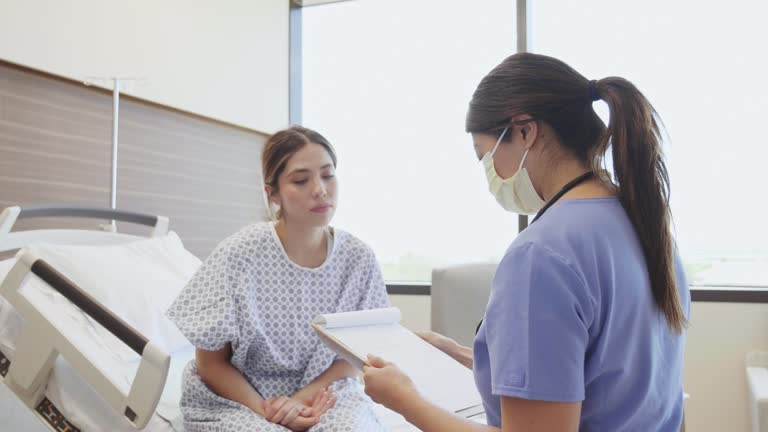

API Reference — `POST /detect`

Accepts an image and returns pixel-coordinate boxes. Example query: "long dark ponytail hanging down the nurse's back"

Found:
[593,77,686,332]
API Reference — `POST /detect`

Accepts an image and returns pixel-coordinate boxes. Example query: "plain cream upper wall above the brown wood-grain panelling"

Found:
[0,0,289,133]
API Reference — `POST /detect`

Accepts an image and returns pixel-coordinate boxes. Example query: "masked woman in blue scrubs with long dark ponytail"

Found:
[365,53,690,432]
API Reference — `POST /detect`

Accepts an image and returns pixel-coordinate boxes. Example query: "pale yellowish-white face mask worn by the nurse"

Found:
[482,128,545,215]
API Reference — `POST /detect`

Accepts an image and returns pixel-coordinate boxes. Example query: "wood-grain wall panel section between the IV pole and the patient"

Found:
[117,101,266,257]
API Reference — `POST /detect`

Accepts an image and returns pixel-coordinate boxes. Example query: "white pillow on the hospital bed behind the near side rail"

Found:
[27,232,200,361]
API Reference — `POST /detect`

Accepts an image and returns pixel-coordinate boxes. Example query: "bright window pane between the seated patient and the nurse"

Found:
[302,0,517,281]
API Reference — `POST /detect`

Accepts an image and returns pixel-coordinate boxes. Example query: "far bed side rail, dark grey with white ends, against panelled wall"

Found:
[0,206,169,237]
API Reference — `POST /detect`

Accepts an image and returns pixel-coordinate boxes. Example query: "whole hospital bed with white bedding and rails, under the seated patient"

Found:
[0,207,444,432]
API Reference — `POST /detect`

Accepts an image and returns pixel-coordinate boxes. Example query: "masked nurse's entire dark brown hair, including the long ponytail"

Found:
[466,53,687,333]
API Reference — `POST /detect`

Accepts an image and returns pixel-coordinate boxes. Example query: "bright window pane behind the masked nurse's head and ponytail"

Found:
[530,0,768,287]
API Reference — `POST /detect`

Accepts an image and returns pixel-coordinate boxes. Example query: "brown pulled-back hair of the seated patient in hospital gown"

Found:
[261,126,336,218]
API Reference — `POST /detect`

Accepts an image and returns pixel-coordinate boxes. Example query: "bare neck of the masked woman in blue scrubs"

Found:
[531,157,616,201]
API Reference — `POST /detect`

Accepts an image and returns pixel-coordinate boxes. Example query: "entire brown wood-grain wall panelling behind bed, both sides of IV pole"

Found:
[0,61,266,258]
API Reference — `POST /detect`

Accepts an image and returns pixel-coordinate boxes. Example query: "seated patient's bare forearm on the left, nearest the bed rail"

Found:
[197,352,264,416]
